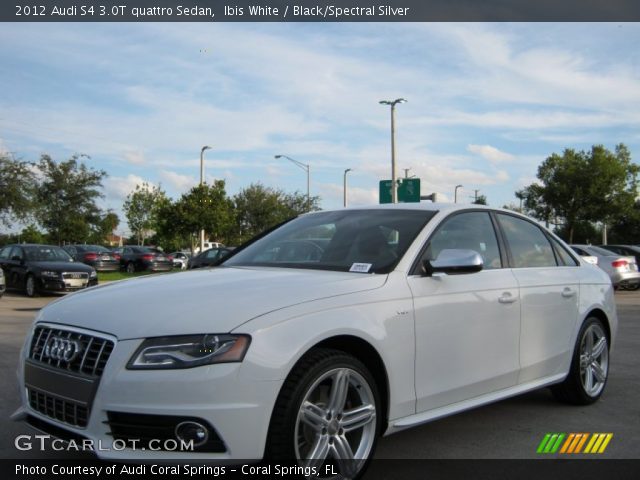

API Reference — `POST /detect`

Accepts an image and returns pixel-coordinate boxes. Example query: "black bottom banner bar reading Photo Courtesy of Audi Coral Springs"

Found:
[0,459,640,480]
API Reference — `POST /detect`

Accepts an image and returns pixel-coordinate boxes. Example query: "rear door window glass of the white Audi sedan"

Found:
[498,215,557,268]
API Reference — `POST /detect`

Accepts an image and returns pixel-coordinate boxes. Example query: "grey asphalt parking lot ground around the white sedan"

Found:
[0,292,640,459]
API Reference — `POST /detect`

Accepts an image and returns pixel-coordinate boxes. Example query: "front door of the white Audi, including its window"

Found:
[408,211,520,412]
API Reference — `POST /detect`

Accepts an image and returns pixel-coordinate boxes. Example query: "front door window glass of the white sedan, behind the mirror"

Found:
[421,212,502,270]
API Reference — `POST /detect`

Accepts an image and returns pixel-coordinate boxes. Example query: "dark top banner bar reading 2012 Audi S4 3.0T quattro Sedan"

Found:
[0,0,640,22]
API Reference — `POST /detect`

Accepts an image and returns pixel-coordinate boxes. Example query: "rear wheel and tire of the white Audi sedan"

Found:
[552,317,609,405]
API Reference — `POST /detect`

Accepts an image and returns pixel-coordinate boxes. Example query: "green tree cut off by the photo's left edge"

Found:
[0,153,35,227]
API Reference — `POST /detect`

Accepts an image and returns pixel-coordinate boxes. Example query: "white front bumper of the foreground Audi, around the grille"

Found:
[16,329,281,460]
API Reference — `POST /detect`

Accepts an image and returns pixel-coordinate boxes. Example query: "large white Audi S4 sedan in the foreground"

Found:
[14,204,617,477]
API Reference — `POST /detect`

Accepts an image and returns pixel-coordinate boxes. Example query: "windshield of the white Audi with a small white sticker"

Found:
[222,210,436,273]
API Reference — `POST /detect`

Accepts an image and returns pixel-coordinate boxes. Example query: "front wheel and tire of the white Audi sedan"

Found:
[266,349,381,478]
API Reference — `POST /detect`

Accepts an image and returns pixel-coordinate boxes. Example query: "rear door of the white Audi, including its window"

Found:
[496,213,580,383]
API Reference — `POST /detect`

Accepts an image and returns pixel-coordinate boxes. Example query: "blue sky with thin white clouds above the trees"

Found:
[0,23,640,235]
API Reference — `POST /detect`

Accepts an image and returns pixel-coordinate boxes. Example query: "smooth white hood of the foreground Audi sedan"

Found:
[37,267,387,340]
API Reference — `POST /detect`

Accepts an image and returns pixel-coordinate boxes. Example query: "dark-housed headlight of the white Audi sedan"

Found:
[127,334,251,370]
